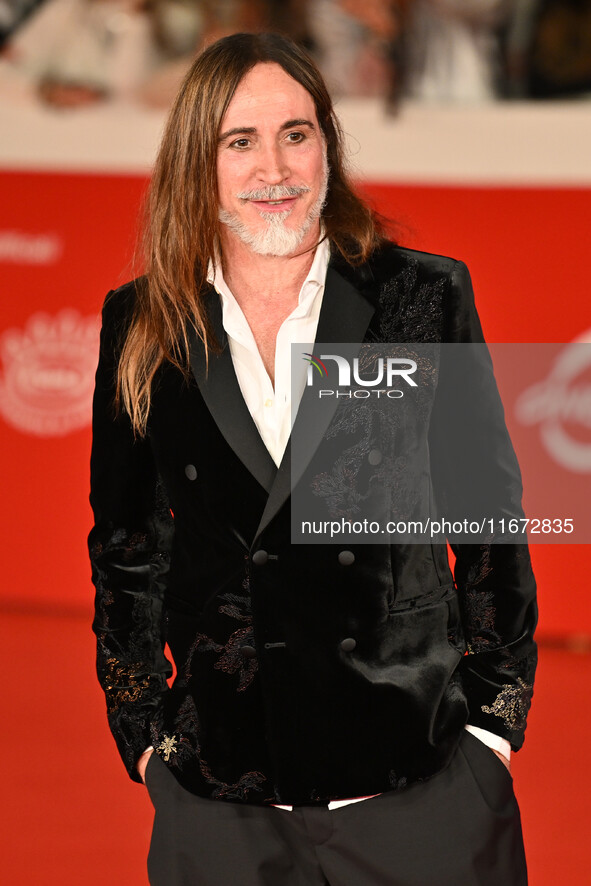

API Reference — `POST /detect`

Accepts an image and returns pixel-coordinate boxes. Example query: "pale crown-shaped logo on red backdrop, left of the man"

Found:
[0,309,100,437]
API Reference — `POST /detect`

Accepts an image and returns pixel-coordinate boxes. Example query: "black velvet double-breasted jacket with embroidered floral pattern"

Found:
[89,244,536,804]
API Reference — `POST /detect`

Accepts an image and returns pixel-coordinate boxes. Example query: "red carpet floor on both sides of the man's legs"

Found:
[0,609,591,886]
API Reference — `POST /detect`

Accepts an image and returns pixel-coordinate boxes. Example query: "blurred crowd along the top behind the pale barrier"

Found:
[0,0,591,112]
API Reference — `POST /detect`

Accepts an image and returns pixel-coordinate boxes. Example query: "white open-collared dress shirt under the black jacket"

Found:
[202,240,511,810]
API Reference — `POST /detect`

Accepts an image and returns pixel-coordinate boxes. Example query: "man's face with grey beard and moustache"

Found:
[217,63,328,255]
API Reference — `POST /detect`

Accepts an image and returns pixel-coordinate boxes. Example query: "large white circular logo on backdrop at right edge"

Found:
[515,329,591,474]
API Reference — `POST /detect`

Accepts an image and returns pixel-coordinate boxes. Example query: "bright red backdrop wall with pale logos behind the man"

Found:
[0,172,591,635]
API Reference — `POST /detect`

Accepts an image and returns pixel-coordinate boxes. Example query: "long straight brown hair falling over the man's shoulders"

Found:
[117,34,384,435]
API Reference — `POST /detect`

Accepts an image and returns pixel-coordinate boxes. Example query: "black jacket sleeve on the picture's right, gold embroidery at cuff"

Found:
[439,262,537,750]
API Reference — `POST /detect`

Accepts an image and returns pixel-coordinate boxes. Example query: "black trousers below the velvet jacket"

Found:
[146,732,527,886]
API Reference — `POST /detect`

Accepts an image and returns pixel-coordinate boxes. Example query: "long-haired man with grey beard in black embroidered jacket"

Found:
[89,34,536,886]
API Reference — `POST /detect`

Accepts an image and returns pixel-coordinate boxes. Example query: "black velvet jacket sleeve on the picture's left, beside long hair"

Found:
[88,284,173,781]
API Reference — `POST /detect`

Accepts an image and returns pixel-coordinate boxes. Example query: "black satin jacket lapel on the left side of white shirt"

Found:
[190,287,277,500]
